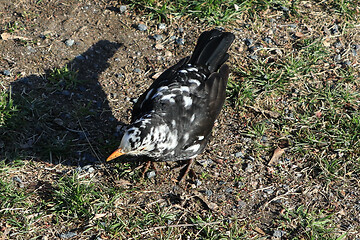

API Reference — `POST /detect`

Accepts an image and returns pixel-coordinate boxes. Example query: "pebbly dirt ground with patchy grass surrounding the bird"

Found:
[0,0,360,240]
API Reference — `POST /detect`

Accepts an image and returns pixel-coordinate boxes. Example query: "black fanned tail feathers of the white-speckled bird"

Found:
[189,29,235,73]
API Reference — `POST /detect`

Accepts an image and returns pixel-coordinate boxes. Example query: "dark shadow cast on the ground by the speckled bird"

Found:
[0,40,127,166]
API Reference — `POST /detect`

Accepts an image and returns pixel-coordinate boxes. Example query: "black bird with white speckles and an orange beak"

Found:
[106,29,235,181]
